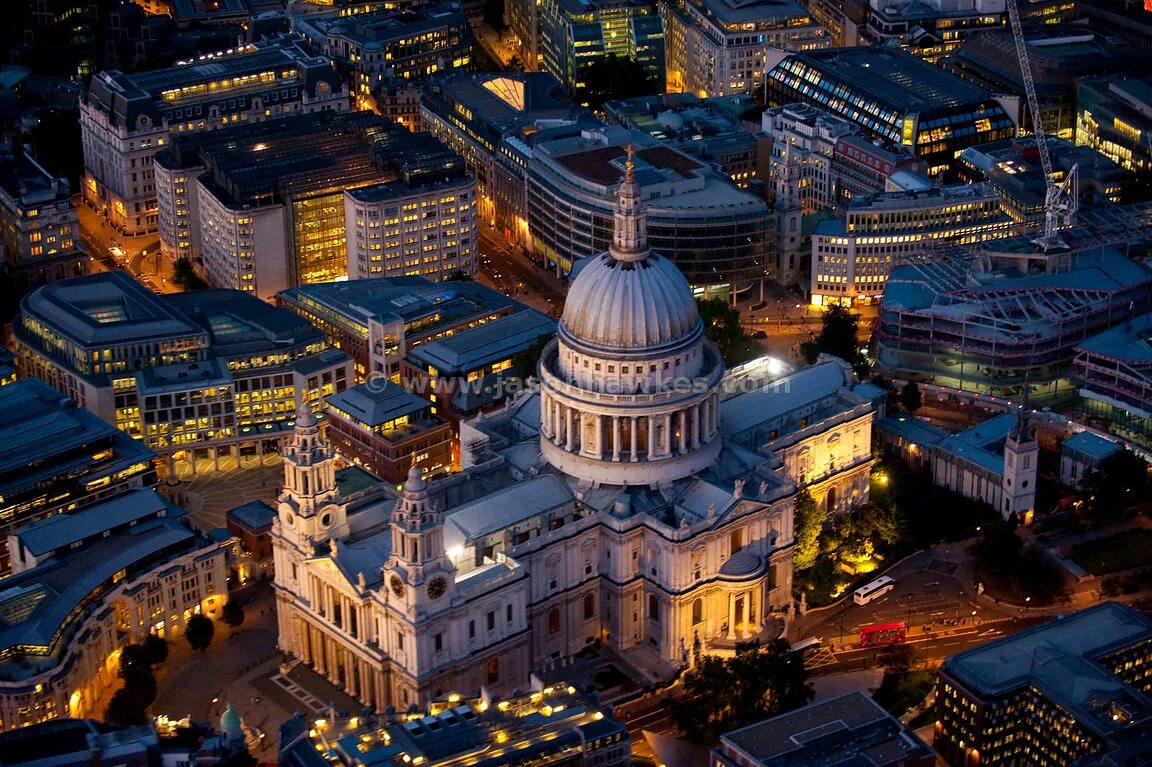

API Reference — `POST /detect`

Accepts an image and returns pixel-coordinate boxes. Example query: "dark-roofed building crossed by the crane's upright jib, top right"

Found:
[945,22,1143,141]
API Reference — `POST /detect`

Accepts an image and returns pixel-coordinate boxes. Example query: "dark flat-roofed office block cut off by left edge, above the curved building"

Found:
[0,378,156,578]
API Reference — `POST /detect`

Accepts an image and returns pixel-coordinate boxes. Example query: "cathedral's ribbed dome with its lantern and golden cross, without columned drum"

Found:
[560,149,704,354]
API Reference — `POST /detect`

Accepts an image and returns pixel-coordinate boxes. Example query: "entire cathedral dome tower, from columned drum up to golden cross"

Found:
[539,149,723,485]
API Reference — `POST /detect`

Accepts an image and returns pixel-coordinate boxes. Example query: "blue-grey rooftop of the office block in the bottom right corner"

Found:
[941,602,1152,735]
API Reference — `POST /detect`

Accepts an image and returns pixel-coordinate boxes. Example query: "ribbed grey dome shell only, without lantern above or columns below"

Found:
[560,252,703,352]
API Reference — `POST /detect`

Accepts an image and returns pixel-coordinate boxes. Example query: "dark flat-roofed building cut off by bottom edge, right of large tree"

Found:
[708,692,935,767]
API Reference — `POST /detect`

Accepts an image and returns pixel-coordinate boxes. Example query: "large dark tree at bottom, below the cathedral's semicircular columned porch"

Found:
[666,639,812,743]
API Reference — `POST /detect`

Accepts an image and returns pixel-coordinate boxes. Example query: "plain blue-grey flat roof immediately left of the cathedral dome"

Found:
[408,309,556,373]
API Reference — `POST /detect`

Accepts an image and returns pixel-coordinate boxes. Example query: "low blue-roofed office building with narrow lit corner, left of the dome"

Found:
[276,276,528,382]
